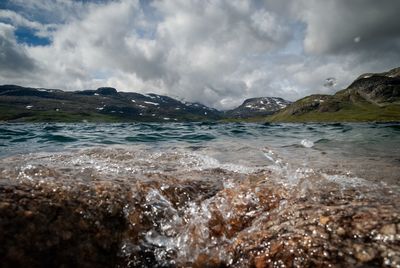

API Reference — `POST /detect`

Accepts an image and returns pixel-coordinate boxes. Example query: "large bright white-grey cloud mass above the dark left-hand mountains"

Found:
[1,1,290,107]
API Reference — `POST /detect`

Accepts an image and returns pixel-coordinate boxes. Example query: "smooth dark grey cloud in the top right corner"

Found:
[294,0,400,54]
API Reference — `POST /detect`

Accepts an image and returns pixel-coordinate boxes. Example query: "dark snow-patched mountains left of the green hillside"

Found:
[0,85,290,122]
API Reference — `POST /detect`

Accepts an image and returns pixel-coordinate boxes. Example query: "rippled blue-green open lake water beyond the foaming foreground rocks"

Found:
[0,123,400,184]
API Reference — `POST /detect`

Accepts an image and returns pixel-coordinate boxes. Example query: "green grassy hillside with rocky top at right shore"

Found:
[265,68,400,122]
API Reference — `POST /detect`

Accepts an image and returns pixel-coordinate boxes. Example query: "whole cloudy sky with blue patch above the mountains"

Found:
[0,0,400,109]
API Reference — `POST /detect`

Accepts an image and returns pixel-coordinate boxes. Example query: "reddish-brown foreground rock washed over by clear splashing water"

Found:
[0,148,400,267]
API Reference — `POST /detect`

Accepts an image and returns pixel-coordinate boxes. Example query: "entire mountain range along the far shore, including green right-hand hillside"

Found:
[0,68,400,122]
